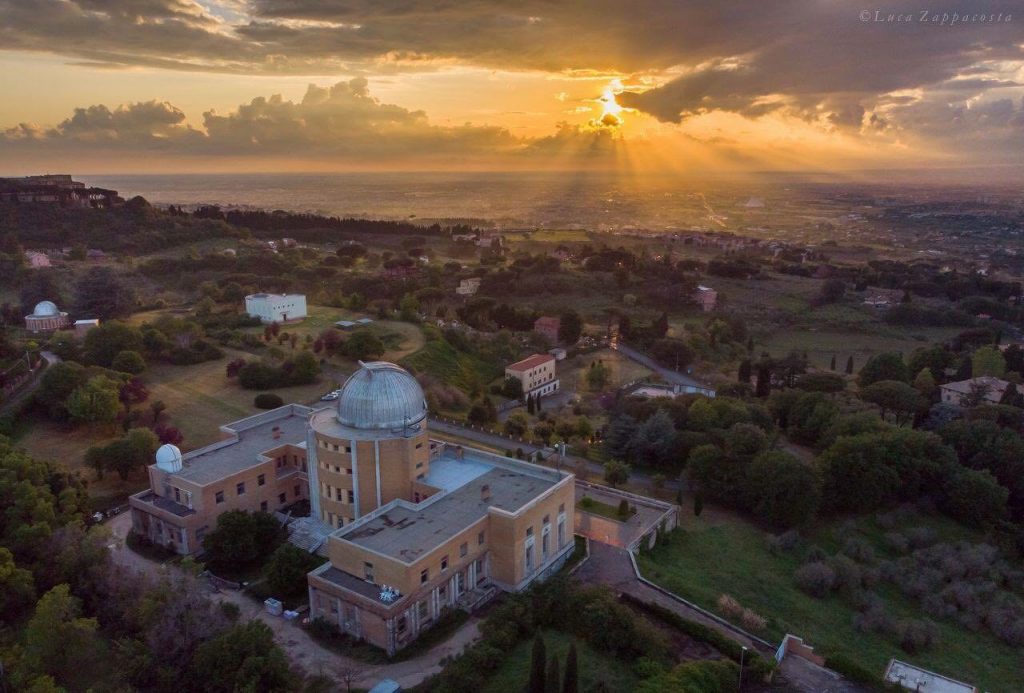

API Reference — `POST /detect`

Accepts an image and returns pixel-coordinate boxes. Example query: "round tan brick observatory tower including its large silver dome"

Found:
[306,361,430,527]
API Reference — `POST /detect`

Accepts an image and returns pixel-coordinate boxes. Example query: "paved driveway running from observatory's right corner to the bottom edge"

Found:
[575,540,867,693]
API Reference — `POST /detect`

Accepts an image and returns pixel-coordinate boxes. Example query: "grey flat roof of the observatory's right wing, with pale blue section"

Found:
[335,448,564,563]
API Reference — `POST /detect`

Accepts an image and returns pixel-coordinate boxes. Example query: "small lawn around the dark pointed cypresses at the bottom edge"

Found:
[481,631,637,693]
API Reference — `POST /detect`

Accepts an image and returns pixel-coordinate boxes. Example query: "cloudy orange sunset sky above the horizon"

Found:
[0,0,1024,173]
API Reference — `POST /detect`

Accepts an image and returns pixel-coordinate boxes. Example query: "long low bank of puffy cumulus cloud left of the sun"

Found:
[0,78,610,164]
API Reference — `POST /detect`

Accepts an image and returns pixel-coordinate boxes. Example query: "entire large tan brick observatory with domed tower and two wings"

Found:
[125,361,574,654]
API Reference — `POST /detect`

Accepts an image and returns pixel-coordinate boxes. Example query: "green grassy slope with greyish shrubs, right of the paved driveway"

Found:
[637,510,1024,691]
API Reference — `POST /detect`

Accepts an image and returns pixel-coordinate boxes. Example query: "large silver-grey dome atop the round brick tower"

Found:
[338,361,427,430]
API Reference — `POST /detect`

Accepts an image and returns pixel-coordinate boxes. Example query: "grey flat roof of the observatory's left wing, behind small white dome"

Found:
[167,404,313,485]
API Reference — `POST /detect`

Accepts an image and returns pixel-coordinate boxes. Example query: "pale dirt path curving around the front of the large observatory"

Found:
[106,512,479,690]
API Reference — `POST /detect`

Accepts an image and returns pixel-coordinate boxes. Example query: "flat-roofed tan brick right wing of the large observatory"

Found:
[308,441,574,654]
